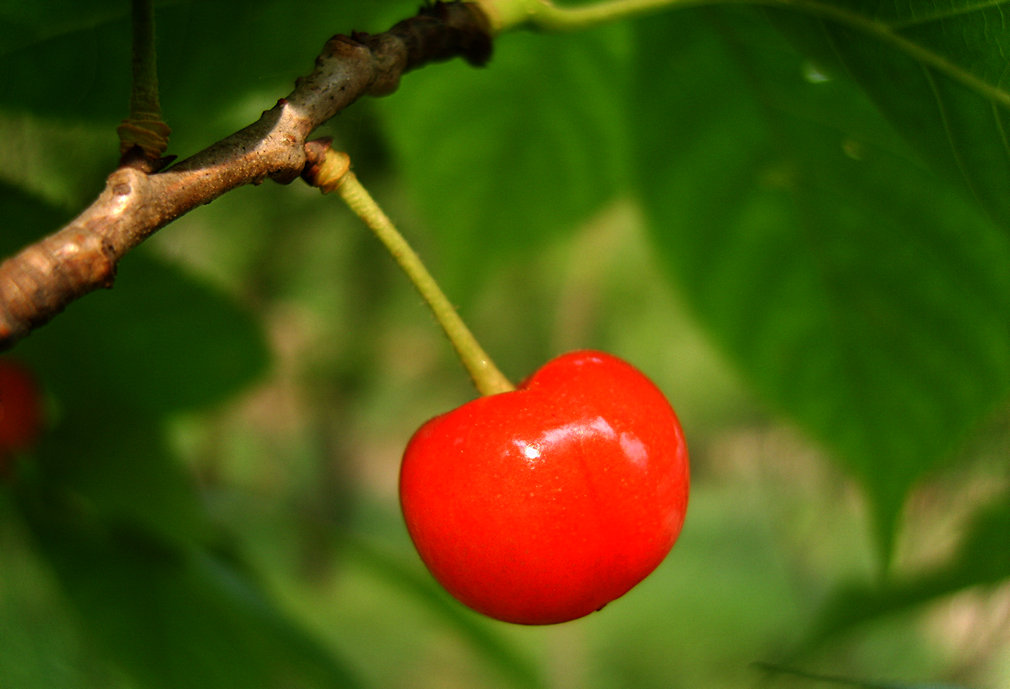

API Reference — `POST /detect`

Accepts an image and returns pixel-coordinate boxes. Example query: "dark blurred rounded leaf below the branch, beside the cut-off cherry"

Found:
[16,251,270,413]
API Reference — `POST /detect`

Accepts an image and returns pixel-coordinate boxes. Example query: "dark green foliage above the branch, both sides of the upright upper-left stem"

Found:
[0,0,416,157]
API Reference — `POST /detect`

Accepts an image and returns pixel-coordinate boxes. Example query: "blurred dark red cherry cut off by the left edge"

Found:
[0,359,42,476]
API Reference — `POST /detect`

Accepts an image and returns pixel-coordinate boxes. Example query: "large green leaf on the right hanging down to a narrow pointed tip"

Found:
[632,9,1010,559]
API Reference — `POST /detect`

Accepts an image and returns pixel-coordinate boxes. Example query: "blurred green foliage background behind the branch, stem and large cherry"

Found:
[0,0,1010,689]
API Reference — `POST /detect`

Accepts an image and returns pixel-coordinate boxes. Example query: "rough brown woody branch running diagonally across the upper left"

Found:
[0,2,491,350]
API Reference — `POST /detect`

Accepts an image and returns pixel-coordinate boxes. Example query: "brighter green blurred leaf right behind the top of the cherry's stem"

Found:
[377,27,626,299]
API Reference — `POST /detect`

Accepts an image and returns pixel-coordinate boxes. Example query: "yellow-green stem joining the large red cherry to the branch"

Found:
[315,150,515,395]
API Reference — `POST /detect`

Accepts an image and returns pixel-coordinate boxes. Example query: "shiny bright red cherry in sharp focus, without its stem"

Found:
[400,352,689,624]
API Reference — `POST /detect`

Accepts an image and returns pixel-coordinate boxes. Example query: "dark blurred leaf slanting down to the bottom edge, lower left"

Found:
[22,482,360,689]
